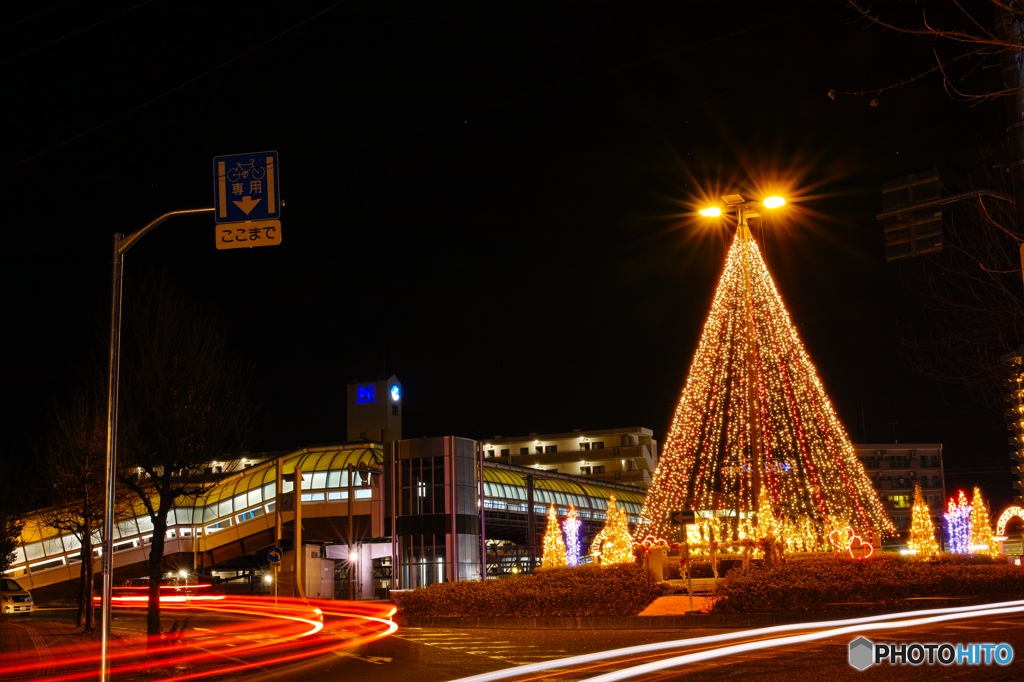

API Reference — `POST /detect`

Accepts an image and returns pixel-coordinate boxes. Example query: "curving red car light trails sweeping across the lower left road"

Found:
[0,586,398,682]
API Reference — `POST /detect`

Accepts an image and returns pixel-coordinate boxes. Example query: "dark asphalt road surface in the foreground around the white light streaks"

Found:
[19,611,1024,682]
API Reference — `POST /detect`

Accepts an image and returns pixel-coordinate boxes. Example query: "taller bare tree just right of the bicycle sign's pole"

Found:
[119,280,256,637]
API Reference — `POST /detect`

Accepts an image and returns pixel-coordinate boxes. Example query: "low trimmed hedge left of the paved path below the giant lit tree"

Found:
[395,564,662,617]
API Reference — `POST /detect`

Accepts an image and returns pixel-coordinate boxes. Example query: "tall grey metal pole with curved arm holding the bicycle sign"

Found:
[99,208,214,682]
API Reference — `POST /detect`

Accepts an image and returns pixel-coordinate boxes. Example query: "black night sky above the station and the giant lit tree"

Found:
[0,0,1012,509]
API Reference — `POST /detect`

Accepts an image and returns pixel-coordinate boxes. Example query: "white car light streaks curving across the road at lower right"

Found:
[451,600,1024,682]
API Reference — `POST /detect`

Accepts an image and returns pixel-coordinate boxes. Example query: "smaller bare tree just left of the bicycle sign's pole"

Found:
[39,385,131,631]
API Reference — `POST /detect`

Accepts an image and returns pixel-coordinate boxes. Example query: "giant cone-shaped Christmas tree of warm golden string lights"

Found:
[635,211,895,540]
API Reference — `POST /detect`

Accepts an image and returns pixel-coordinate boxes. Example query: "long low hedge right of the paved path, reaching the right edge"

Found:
[712,555,1024,613]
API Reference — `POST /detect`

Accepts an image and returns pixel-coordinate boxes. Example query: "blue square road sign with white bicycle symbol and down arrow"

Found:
[213,152,281,223]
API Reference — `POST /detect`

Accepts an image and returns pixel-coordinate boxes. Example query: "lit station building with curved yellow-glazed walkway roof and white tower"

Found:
[5,375,656,603]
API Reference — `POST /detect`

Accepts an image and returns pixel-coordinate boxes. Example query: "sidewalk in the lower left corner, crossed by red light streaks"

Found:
[0,616,139,679]
